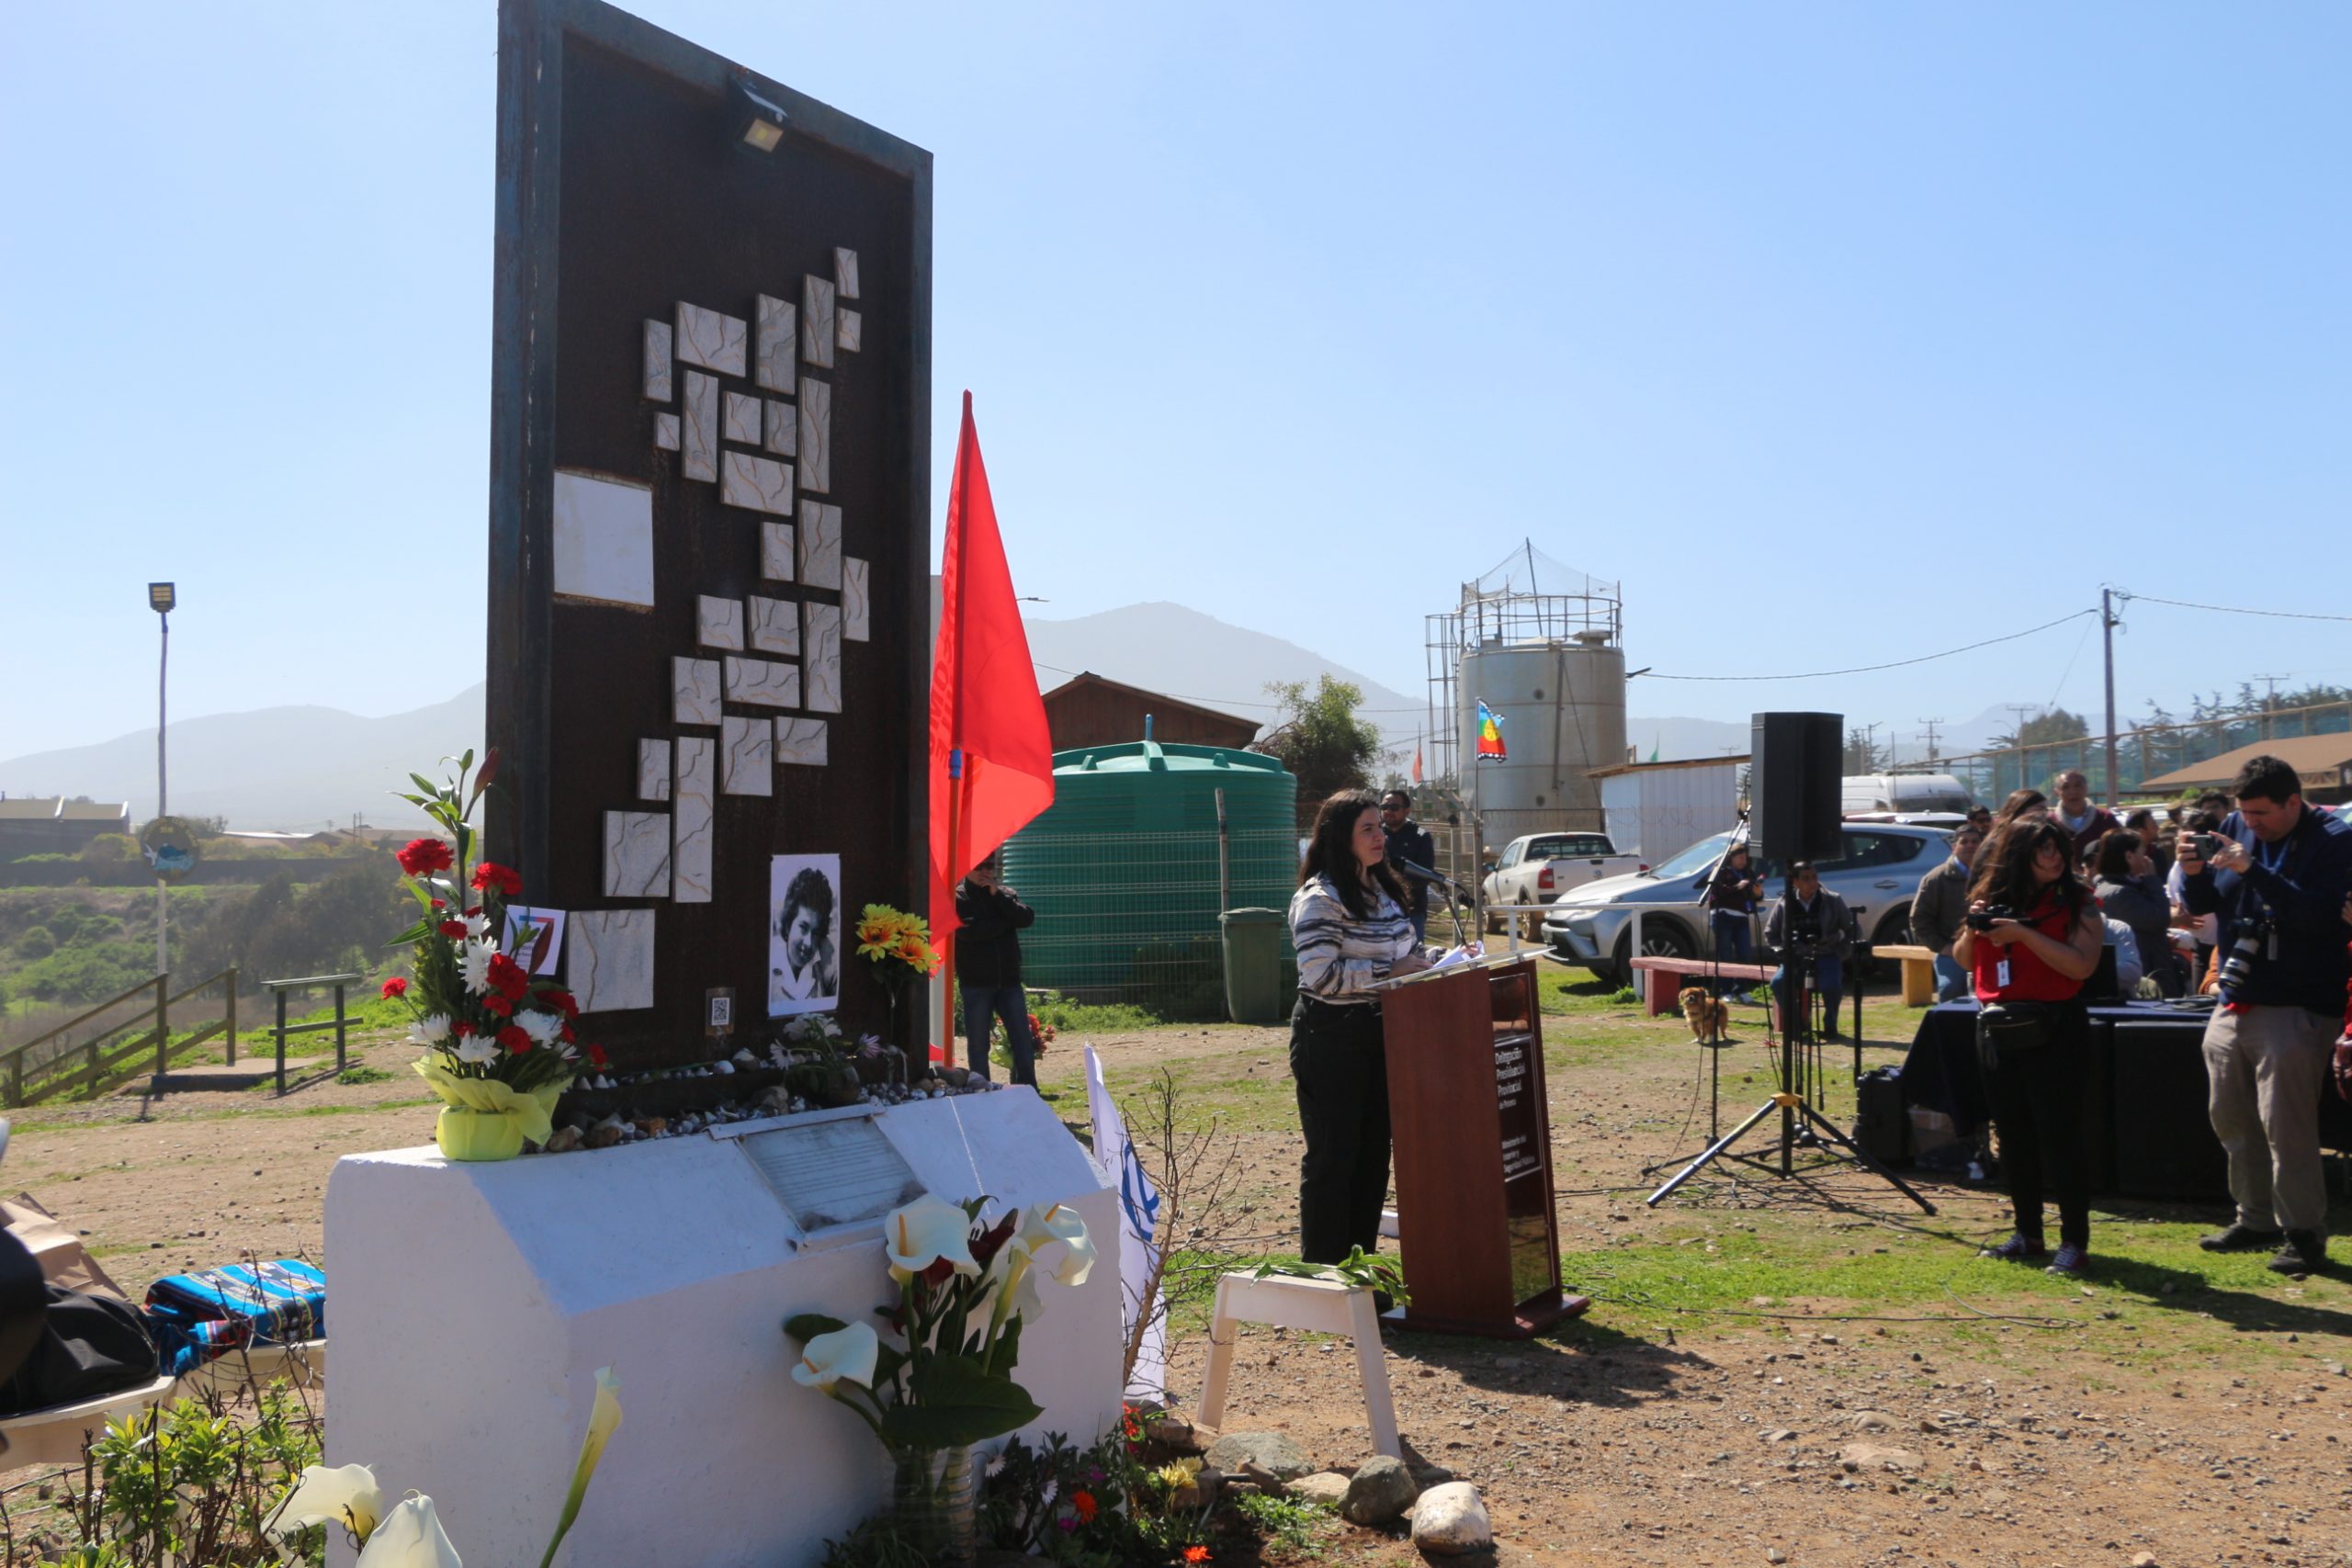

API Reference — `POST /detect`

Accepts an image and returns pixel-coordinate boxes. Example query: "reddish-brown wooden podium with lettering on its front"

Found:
[1381,957,1592,1340]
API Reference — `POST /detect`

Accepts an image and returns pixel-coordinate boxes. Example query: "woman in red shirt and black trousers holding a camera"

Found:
[1952,820,2105,1274]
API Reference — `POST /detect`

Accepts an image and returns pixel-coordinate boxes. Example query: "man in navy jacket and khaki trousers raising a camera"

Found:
[2178,757,2352,1274]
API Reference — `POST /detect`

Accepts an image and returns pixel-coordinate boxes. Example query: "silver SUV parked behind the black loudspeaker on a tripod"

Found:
[1543,823,1952,985]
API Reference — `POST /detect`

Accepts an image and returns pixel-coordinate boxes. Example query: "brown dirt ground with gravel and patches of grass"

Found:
[5,1009,2352,1568]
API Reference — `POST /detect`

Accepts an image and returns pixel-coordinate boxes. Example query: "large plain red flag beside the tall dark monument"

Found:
[932,392,1054,938]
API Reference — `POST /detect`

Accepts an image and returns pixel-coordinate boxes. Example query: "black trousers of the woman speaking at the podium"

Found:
[1291,997,1387,1262]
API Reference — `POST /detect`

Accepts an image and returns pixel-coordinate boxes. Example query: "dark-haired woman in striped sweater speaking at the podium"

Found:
[1291,790,1430,1262]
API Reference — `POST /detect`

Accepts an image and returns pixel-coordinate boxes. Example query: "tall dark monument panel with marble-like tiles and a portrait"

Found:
[484,0,932,1065]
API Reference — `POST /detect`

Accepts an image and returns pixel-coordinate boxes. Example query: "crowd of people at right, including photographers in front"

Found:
[1912,757,2352,1274]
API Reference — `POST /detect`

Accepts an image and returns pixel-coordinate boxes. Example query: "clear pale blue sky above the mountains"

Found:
[0,0,2352,757]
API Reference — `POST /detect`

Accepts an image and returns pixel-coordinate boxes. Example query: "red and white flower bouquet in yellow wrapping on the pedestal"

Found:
[383,752,588,1159]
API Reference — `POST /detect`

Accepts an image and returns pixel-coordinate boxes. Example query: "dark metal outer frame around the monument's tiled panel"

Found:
[482,0,932,968]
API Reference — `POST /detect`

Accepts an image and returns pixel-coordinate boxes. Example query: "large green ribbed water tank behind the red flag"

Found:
[1004,740,1298,1018]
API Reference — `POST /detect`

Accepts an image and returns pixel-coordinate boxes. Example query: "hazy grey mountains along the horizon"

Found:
[0,602,2011,832]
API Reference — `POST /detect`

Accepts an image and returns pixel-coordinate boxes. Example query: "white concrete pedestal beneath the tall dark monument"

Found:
[327,1089,1122,1568]
